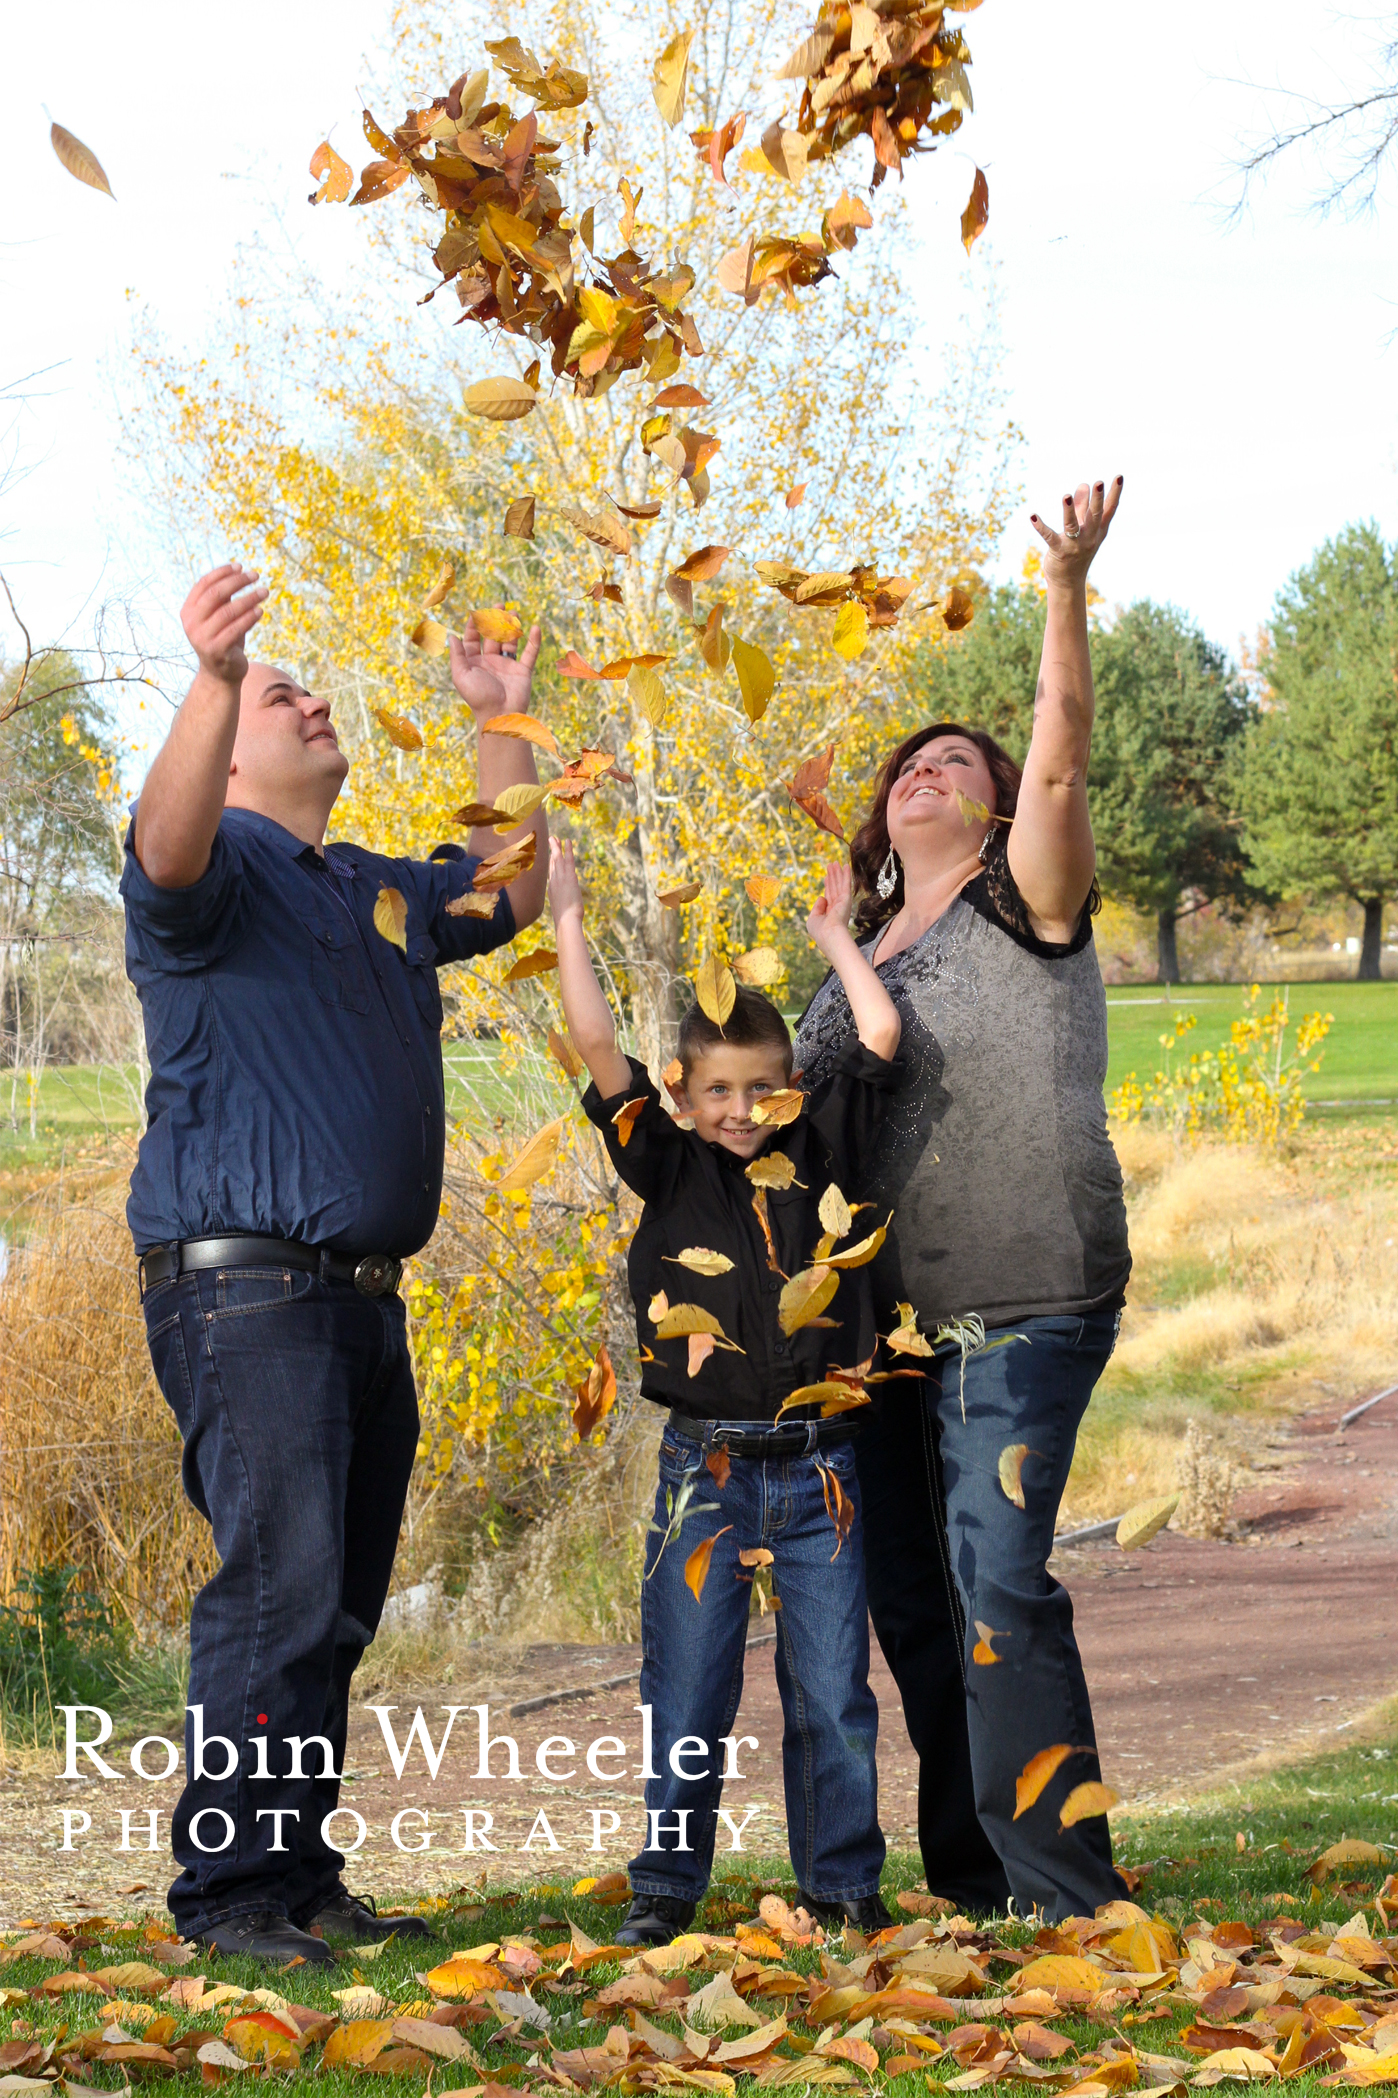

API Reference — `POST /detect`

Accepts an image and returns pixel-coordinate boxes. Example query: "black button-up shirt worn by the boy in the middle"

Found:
[584,1041,901,1420]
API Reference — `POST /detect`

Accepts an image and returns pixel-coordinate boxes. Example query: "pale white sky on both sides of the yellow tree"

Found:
[0,0,1398,755]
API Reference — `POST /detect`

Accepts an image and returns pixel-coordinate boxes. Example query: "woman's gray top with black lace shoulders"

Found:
[796,866,1131,1330]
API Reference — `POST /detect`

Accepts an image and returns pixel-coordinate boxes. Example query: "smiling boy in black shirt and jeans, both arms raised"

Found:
[548,839,901,1945]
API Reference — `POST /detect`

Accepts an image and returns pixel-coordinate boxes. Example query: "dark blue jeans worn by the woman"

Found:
[859,1311,1125,1922]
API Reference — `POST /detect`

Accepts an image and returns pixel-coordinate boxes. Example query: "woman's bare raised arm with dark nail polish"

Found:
[1010,474,1123,940]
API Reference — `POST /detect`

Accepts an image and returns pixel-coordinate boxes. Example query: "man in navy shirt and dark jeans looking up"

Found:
[122,566,548,1962]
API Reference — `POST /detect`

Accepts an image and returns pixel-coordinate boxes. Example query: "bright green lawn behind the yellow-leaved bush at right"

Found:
[1106,982,1398,1106]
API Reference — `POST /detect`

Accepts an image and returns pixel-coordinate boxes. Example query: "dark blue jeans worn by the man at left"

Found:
[145,1267,418,1934]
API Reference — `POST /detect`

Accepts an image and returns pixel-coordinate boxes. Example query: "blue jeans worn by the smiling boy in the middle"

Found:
[630,1420,884,1903]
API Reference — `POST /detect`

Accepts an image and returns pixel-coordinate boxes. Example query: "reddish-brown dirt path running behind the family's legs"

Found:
[0,1397,1398,1922]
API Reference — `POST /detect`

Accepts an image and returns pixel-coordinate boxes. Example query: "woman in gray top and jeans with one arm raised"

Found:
[798,478,1131,1922]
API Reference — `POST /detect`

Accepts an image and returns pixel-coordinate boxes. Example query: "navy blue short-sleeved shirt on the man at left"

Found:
[122,808,514,1259]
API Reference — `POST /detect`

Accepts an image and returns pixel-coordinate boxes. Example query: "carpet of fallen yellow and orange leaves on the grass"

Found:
[0,1854,1398,2098]
